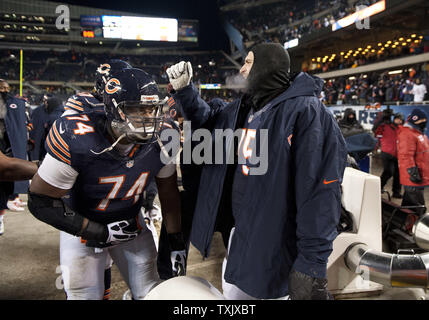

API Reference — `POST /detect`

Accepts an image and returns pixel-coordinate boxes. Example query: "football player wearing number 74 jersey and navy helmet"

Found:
[28,68,186,299]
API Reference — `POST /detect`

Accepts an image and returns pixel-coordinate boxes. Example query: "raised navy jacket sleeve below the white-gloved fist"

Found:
[174,83,226,129]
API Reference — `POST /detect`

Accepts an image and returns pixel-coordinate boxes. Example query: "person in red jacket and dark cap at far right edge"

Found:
[398,108,429,215]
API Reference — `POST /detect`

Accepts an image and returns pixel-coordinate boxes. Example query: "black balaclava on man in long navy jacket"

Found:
[246,43,292,110]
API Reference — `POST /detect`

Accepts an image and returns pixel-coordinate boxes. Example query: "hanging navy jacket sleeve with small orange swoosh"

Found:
[292,99,347,278]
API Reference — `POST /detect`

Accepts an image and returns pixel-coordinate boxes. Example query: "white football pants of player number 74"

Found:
[60,216,161,300]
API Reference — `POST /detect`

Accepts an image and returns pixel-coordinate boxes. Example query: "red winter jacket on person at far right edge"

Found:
[398,124,429,186]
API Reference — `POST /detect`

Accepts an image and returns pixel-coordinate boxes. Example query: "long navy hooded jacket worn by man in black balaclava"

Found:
[174,73,347,299]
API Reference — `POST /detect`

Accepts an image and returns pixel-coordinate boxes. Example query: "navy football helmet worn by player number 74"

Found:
[103,68,168,143]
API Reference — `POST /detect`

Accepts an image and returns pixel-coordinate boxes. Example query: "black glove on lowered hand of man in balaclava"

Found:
[289,269,333,300]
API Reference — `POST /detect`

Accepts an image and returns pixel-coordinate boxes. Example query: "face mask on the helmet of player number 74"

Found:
[112,101,168,144]
